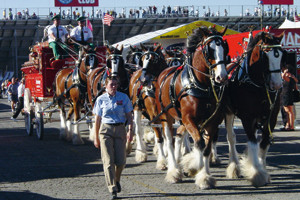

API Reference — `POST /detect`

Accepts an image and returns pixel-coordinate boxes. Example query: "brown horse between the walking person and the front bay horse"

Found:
[129,44,168,163]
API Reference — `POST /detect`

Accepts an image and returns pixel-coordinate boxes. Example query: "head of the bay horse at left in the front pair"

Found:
[187,27,229,83]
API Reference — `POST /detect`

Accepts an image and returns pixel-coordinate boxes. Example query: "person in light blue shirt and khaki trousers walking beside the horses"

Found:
[93,76,133,199]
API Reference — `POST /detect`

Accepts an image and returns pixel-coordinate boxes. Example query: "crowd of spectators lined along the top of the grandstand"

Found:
[2,5,297,20]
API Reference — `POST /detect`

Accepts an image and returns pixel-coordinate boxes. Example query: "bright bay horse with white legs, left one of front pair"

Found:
[155,26,228,189]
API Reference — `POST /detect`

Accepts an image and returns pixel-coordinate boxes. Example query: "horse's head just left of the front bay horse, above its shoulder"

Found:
[140,44,167,84]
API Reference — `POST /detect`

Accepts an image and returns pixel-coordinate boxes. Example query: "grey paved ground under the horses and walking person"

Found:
[0,99,300,200]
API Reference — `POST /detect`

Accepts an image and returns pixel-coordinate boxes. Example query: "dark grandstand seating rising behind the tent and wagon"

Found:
[0,16,285,76]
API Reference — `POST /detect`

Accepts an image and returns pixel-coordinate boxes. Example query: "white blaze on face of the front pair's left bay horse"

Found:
[210,41,227,83]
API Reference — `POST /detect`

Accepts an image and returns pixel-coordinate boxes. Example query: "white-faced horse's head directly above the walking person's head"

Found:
[106,45,124,76]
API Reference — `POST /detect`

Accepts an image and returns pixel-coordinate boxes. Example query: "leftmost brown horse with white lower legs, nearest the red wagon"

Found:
[53,46,98,145]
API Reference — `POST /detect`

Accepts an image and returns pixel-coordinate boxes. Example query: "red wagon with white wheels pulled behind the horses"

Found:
[21,42,106,140]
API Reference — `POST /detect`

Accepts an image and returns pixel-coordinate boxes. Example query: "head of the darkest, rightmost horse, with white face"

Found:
[247,32,284,90]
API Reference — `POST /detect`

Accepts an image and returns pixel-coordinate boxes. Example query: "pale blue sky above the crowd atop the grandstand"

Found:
[0,0,300,15]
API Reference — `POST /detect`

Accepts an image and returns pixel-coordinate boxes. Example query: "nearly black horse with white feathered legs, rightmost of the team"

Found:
[218,32,285,187]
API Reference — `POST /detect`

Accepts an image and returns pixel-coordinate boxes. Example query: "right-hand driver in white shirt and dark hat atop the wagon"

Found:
[70,16,94,52]
